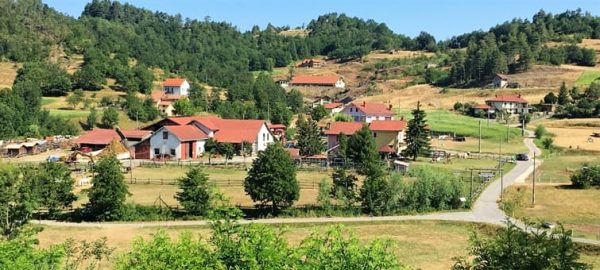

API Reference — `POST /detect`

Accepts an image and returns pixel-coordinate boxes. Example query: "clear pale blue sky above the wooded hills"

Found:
[43,0,600,39]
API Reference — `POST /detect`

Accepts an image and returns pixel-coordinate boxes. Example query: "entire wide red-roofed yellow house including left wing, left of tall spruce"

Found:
[324,119,407,155]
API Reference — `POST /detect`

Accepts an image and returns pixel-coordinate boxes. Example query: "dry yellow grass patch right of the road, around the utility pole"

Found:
[506,185,600,239]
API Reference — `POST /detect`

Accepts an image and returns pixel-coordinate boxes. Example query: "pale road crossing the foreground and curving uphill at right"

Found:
[36,132,600,245]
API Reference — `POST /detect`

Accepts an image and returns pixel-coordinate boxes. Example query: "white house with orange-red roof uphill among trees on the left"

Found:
[151,78,190,116]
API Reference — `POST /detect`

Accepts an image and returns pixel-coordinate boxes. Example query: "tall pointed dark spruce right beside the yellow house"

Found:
[402,102,430,160]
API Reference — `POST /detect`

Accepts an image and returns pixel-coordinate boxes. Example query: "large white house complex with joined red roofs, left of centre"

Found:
[141,116,275,160]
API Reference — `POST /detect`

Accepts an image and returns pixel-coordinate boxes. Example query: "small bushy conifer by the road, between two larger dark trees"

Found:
[175,167,215,216]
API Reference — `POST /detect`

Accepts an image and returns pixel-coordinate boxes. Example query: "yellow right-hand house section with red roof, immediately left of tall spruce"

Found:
[369,120,406,155]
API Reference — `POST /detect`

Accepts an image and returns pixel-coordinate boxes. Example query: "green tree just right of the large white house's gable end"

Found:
[296,116,323,156]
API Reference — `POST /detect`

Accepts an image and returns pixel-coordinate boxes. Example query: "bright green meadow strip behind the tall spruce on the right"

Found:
[398,110,521,142]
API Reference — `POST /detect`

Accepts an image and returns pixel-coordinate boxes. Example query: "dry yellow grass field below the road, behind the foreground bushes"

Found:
[38,221,492,269]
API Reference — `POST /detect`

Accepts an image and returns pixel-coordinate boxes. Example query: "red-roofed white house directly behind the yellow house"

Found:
[342,101,395,123]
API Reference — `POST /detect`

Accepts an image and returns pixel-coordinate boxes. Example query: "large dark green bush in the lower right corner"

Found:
[452,222,590,270]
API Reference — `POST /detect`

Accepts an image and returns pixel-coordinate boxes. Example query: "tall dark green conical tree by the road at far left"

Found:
[86,156,129,220]
